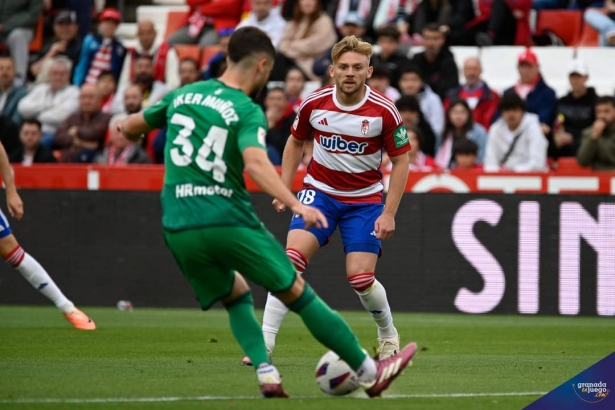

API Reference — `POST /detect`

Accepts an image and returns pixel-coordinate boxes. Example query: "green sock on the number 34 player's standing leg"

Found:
[225,292,269,368]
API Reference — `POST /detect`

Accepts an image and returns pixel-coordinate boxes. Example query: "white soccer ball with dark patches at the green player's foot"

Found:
[316,350,360,396]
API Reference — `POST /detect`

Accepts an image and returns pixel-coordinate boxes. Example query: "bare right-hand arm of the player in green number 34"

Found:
[242,147,328,229]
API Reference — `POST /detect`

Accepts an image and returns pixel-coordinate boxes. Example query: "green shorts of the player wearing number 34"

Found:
[164,226,296,310]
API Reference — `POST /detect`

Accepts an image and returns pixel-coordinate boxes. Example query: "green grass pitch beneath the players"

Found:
[0,306,615,410]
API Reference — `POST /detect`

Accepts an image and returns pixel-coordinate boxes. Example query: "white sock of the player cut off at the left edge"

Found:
[7,247,75,313]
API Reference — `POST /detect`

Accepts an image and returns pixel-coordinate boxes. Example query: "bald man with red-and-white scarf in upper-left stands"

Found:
[118,20,179,89]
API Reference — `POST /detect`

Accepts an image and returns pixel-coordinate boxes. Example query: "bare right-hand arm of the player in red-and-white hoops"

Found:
[374,152,410,241]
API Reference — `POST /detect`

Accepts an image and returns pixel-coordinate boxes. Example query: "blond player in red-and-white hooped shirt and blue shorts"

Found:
[244,36,410,364]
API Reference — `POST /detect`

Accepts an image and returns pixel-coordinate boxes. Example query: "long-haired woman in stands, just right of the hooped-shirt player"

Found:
[436,100,487,169]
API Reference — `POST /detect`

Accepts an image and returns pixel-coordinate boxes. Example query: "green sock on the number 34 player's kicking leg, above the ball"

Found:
[288,283,367,370]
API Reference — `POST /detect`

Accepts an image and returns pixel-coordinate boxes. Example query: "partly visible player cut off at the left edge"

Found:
[0,138,96,330]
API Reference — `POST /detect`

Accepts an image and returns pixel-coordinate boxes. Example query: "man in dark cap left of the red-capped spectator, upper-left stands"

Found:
[30,10,81,84]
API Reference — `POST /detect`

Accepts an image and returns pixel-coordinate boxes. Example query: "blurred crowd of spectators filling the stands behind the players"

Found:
[0,0,615,172]
